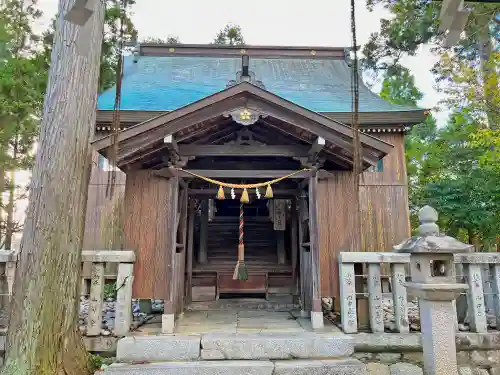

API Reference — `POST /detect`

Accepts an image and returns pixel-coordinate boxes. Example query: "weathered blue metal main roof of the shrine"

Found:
[97,56,421,112]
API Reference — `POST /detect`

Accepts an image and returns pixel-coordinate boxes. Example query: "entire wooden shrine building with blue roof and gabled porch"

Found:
[93,44,425,331]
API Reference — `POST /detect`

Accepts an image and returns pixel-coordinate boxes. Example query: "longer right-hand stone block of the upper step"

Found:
[201,332,354,360]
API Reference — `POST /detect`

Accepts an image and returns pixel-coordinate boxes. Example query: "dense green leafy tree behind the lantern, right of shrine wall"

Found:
[419,112,500,246]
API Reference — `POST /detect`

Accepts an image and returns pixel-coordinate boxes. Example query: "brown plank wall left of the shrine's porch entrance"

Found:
[125,170,178,301]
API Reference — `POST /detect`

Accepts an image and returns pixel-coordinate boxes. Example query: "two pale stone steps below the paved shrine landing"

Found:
[105,332,366,375]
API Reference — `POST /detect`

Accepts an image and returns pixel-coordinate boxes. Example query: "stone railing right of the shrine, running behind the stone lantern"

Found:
[339,252,500,333]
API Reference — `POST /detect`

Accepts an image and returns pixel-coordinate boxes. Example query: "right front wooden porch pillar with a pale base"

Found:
[309,172,323,329]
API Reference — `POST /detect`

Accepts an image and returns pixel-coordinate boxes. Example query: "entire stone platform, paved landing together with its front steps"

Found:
[100,310,366,375]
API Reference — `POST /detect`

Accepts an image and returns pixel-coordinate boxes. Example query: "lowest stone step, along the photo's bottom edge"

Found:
[101,359,366,375]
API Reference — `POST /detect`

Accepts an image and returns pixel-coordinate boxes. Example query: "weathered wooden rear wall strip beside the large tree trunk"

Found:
[83,152,125,250]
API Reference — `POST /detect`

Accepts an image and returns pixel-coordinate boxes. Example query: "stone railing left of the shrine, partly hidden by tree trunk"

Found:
[0,250,135,337]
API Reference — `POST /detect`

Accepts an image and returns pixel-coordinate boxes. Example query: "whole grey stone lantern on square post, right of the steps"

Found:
[394,206,473,375]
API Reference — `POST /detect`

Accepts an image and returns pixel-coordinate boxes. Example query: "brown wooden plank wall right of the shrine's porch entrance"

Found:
[318,134,410,297]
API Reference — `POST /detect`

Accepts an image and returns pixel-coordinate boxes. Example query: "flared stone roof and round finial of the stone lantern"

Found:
[394,206,474,254]
